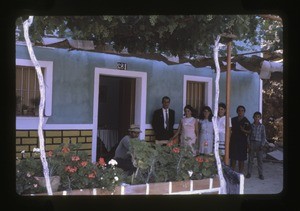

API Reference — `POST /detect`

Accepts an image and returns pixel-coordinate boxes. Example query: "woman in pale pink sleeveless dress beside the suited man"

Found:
[172,105,199,156]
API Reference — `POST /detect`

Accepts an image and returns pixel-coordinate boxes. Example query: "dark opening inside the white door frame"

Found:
[96,75,136,161]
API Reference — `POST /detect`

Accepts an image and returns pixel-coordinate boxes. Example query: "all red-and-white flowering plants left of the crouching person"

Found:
[16,143,125,194]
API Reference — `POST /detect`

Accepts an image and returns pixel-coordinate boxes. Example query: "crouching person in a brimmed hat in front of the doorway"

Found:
[114,125,142,176]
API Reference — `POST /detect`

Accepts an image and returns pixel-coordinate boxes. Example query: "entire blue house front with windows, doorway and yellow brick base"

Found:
[16,43,262,161]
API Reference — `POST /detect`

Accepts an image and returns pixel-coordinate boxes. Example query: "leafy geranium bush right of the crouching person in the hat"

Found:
[130,140,217,184]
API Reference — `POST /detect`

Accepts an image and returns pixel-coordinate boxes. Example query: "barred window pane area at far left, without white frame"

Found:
[16,66,45,116]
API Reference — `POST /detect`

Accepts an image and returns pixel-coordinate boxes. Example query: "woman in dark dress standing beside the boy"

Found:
[229,105,251,174]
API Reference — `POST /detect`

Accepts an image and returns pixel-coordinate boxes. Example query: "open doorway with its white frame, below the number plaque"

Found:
[92,68,147,161]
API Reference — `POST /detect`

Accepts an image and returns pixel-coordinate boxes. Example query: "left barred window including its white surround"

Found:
[16,59,53,130]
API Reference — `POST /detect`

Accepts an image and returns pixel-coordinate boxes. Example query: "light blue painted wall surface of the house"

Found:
[16,45,259,124]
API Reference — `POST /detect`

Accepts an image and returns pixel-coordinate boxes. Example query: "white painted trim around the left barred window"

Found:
[16,59,53,130]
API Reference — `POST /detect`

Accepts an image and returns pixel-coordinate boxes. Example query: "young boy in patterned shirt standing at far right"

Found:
[246,111,266,180]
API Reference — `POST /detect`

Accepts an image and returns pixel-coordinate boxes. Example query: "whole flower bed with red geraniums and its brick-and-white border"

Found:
[17,140,220,195]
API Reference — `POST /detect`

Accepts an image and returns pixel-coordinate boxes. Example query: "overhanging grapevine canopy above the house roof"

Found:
[16,15,276,57]
